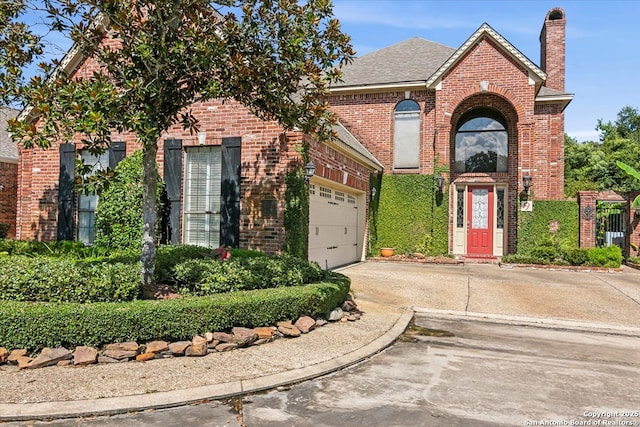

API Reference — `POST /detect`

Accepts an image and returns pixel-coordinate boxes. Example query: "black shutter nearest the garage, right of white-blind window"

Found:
[220,137,241,248]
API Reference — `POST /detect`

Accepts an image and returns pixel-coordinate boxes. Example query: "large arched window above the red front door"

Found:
[455,109,509,173]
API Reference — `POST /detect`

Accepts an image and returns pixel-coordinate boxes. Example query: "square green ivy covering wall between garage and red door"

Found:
[370,174,449,256]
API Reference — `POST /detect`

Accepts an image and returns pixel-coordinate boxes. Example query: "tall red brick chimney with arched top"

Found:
[540,7,567,92]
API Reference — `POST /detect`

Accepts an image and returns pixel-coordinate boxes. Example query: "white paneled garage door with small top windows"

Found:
[309,183,360,269]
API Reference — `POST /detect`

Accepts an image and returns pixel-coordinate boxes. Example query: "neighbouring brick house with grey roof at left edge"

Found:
[0,107,19,238]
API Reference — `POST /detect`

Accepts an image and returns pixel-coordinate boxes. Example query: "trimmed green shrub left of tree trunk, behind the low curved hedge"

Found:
[0,255,140,303]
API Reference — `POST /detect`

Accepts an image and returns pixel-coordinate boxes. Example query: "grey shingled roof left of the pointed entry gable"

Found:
[332,37,456,88]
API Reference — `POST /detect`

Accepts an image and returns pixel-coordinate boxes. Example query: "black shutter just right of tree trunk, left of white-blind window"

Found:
[163,139,182,245]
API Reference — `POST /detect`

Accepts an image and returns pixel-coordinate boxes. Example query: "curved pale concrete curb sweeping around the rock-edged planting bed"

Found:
[0,309,414,422]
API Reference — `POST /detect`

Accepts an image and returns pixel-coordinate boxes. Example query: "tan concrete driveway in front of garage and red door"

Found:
[341,262,640,328]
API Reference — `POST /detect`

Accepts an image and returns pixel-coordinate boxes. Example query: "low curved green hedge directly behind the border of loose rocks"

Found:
[0,273,350,350]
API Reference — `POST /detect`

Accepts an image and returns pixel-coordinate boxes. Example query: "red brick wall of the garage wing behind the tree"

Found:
[18,95,369,253]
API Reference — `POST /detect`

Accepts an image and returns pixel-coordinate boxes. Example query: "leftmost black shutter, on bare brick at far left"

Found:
[57,144,76,240]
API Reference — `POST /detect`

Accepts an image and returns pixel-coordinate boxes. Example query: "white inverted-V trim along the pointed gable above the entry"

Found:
[427,23,547,89]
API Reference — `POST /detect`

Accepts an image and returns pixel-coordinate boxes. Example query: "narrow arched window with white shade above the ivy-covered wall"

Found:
[393,99,420,169]
